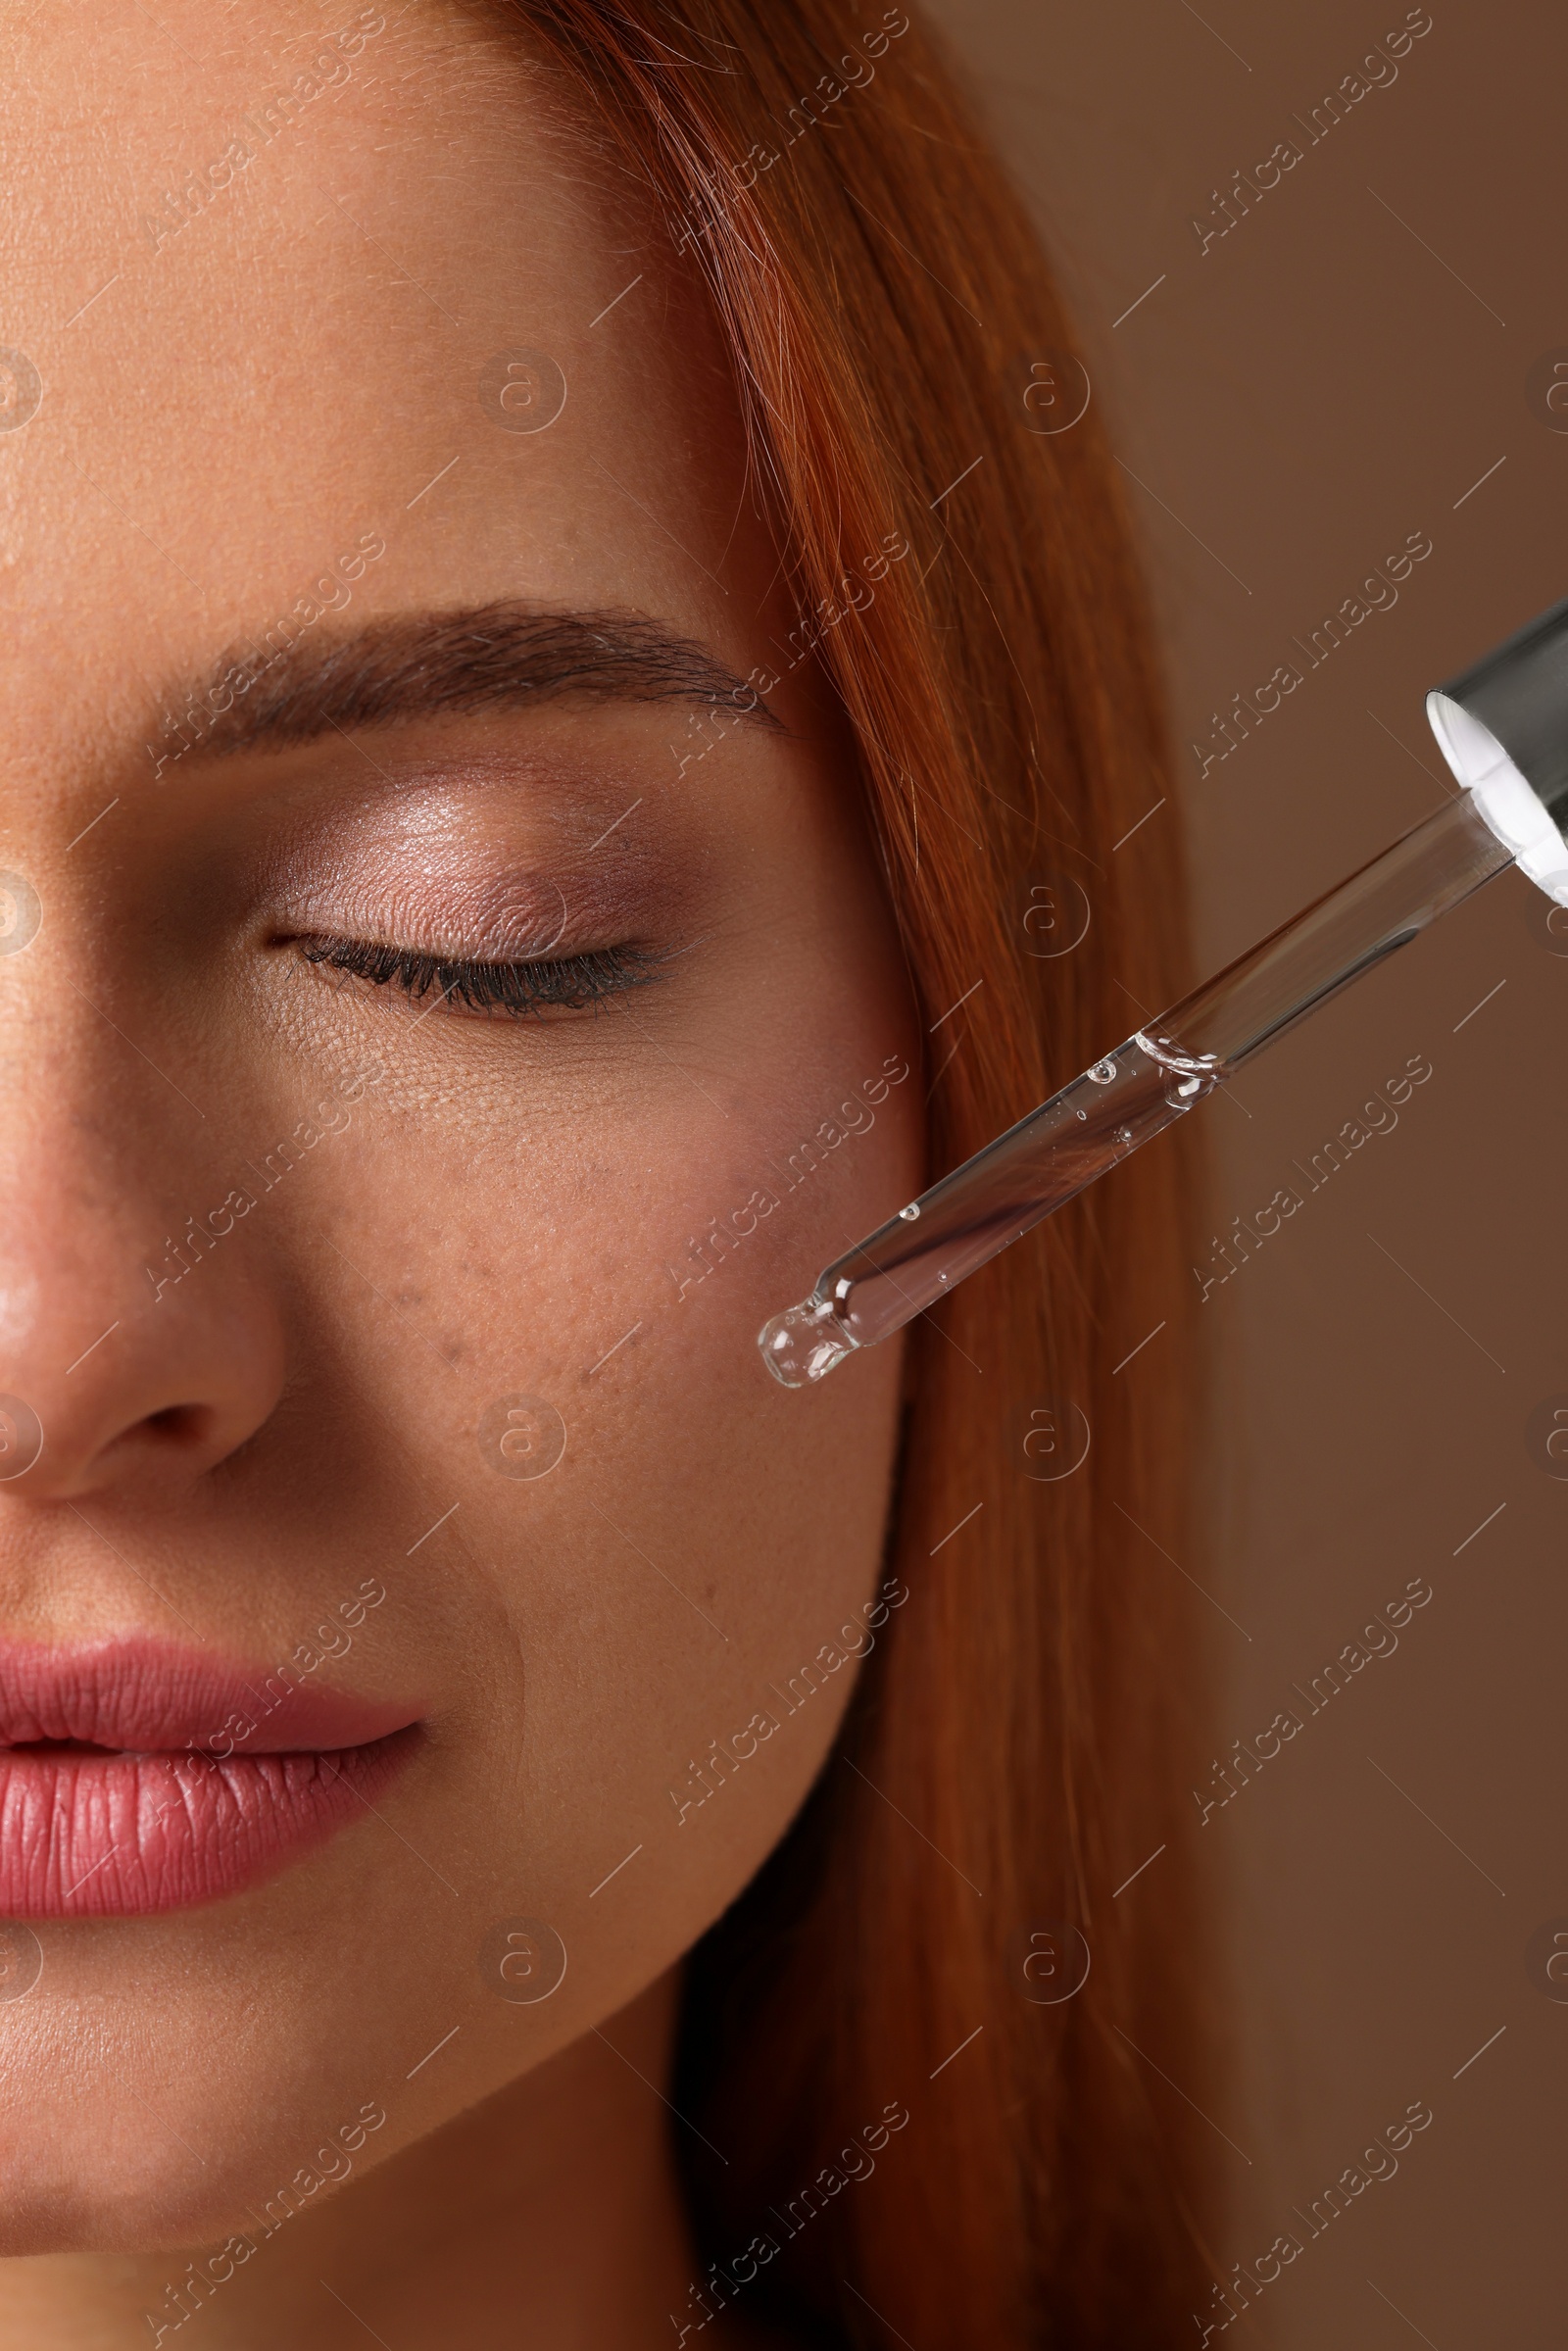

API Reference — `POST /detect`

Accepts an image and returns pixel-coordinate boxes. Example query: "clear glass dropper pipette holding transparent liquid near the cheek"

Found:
[757,602,1568,1387]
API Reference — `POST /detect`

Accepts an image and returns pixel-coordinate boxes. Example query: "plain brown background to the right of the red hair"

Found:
[938,0,1568,2351]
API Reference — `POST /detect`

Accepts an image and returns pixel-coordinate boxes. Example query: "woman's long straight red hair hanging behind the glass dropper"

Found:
[505,0,1208,2351]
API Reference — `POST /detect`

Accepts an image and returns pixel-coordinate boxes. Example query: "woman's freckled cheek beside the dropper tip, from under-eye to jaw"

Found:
[286,973,921,2032]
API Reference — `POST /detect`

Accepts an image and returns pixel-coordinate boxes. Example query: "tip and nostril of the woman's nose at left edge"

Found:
[0,1102,284,1516]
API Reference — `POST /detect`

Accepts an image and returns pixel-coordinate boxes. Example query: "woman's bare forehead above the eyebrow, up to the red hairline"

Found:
[0,0,741,780]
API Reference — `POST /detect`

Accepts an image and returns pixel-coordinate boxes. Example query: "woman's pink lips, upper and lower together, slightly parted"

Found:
[0,1639,420,1919]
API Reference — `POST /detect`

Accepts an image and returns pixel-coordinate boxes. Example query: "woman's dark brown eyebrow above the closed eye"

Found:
[165,600,783,755]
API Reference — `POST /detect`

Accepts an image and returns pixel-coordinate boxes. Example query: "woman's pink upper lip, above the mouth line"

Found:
[0,1637,420,1756]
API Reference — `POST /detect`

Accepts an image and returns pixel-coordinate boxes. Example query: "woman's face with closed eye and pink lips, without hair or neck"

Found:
[0,0,921,2252]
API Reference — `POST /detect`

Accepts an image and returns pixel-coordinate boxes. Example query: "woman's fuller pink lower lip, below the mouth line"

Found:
[0,1726,418,1919]
